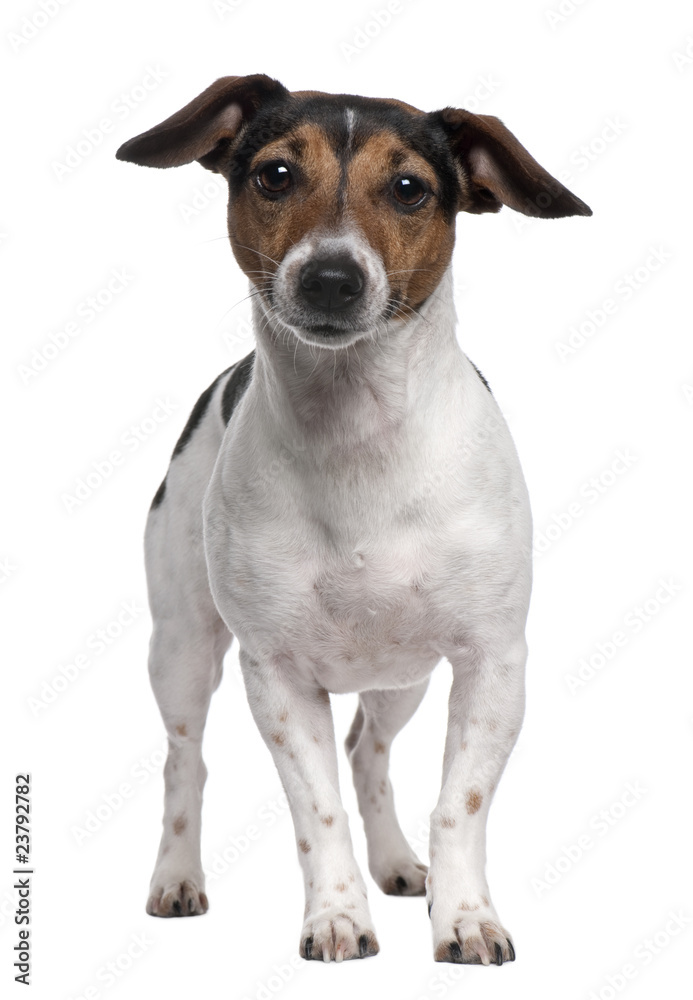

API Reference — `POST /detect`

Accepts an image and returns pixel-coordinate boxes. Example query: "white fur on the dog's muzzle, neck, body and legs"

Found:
[142,234,531,964]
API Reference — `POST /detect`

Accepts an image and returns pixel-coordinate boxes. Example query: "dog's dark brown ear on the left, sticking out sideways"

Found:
[116,73,289,170]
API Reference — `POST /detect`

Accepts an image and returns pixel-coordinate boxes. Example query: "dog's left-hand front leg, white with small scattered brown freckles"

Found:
[240,651,379,962]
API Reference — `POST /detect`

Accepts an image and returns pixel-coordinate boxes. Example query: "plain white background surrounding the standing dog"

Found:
[0,0,693,1000]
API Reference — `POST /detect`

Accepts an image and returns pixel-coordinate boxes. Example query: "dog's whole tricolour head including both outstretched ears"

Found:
[116,75,592,348]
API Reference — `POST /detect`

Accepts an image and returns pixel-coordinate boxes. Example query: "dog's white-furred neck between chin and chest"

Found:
[253,268,460,443]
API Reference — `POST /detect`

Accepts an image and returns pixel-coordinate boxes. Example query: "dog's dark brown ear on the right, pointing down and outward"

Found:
[436,108,592,219]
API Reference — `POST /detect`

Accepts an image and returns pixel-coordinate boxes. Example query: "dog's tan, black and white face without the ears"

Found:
[222,94,460,344]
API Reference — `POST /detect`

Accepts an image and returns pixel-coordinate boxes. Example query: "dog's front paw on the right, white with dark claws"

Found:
[431,903,515,965]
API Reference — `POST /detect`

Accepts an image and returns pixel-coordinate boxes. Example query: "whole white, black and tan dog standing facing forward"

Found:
[116,74,592,965]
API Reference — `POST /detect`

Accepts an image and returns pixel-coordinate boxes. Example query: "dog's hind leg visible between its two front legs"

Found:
[346,678,428,896]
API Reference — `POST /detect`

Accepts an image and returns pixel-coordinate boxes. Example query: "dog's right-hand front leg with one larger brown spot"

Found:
[426,638,527,965]
